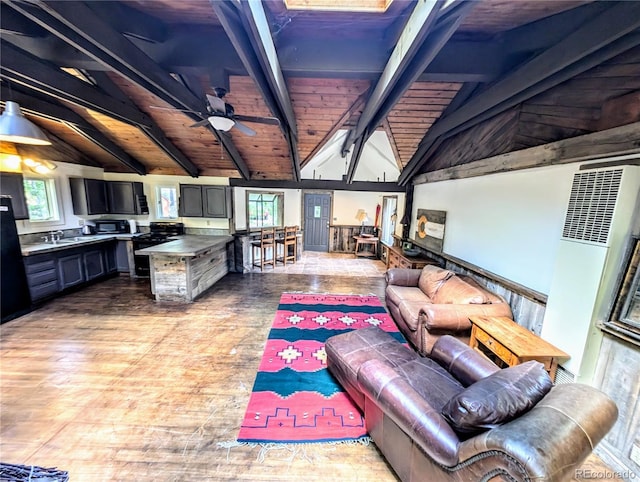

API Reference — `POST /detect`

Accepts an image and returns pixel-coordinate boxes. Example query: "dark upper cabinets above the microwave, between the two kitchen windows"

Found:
[69,178,149,215]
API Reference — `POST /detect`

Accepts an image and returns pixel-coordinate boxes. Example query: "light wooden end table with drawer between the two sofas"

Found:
[469,316,569,380]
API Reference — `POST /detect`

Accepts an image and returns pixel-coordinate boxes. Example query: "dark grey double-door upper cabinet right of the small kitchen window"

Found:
[180,184,231,218]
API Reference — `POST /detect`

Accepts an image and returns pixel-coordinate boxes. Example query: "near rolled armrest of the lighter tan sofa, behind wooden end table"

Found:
[419,303,511,332]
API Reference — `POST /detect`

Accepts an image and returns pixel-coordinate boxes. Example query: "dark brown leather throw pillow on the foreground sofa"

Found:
[442,360,553,435]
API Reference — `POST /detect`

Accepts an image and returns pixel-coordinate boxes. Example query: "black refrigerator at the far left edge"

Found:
[0,196,31,323]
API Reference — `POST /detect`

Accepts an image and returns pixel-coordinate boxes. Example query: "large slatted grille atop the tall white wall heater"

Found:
[562,169,622,244]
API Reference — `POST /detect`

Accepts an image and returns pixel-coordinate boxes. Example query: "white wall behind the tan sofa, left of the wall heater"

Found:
[410,164,579,294]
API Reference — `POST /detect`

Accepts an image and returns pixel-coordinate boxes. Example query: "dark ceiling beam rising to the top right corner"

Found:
[398,2,640,185]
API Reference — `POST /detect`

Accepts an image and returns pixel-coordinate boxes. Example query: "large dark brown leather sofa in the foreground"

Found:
[325,327,617,482]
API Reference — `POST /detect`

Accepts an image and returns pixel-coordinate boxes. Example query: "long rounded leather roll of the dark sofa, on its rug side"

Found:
[358,359,459,466]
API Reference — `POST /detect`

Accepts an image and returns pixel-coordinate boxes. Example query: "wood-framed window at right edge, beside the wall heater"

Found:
[605,238,640,344]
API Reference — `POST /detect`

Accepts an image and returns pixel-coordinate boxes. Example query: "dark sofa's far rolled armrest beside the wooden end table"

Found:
[429,335,500,387]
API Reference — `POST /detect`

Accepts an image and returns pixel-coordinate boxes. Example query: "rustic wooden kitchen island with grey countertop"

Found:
[135,235,233,302]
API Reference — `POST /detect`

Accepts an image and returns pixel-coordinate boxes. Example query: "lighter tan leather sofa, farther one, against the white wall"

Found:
[385,265,512,355]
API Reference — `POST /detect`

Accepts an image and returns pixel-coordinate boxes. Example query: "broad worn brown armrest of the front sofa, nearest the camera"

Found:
[459,383,618,480]
